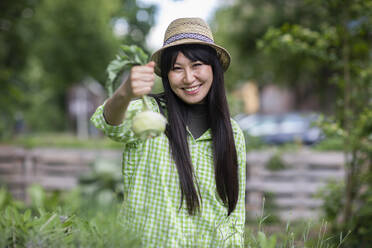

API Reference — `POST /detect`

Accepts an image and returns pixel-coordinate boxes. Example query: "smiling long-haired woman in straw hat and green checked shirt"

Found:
[92,18,245,247]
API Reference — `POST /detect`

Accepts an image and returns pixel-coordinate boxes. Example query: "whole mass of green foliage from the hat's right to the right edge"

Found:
[216,0,372,247]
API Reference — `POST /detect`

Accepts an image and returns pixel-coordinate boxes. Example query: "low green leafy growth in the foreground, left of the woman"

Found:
[0,186,140,247]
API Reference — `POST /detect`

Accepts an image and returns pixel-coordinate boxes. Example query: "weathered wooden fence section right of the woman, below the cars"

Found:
[246,149,345,220]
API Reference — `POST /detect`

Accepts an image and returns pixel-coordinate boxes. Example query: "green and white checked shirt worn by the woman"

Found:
[91,98,246,248]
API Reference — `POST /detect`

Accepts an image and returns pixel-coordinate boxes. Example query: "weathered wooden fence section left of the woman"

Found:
[0,147,121,200]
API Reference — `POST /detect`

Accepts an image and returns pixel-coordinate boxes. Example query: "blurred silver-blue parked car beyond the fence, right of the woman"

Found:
[234,112,323,145]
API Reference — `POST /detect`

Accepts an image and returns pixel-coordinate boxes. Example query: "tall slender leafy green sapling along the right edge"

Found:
[258,0,372,244]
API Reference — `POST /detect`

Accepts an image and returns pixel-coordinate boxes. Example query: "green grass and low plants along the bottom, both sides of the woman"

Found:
[0,186,349,248]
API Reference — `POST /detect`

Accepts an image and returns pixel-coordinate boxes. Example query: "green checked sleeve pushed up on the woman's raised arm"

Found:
[90,100,147,144]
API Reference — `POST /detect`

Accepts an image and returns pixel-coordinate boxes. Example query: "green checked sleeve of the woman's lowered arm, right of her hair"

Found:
[231,120,246,243]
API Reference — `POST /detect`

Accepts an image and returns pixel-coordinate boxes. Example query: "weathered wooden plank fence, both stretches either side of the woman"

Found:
[0,147,344,220]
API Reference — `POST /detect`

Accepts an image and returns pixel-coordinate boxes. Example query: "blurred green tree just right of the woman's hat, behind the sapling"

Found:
[212,0,335,110]
